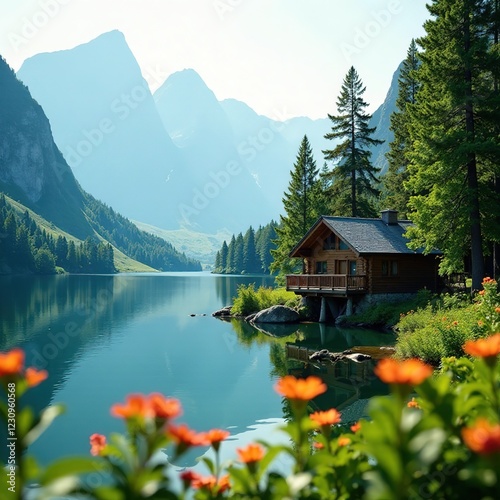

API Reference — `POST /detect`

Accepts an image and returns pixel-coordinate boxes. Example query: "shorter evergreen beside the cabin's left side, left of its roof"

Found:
[271,136,320,277]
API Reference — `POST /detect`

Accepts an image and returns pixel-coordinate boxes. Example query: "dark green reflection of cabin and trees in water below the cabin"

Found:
[226,320,395,423]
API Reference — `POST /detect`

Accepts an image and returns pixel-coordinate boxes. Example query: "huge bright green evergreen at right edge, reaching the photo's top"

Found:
[408,0,500,290]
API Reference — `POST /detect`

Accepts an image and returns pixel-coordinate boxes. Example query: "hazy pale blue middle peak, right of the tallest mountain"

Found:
[153,69,275,232]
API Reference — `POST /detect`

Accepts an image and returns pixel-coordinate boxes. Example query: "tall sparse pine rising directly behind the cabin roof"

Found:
[323,67,383,217]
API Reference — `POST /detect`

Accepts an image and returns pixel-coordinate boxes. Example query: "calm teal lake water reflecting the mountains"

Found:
[0,273,393,466]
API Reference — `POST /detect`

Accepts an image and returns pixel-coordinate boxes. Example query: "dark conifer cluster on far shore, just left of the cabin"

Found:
[213,221,277,274]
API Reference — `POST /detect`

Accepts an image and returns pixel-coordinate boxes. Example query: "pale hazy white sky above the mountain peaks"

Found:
[0,0,428,119]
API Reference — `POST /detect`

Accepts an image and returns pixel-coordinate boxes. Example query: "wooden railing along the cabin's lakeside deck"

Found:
[286,274,367,293]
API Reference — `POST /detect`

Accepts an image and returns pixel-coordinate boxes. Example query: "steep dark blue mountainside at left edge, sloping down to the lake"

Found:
[0,54,200,270]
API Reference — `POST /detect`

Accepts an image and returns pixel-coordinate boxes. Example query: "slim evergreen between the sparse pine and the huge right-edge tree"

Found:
[382,40,420,217]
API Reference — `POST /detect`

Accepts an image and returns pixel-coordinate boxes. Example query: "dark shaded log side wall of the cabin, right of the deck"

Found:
[368,254,440,294]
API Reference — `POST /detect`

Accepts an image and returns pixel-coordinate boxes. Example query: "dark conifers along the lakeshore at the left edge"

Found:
[0,194,116,274]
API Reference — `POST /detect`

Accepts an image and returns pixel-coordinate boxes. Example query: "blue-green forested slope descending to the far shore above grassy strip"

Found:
[85,193,201,271]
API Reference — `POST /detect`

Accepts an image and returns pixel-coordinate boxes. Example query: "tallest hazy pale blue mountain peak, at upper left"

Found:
[18,31,182,227]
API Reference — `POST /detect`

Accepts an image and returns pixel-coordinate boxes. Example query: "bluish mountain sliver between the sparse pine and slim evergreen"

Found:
[369,62,403,176]
